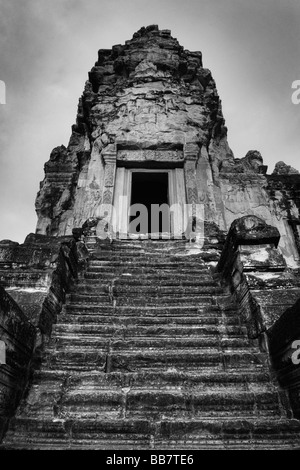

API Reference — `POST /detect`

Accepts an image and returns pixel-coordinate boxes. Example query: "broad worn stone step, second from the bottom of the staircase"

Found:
[19,384,282,419]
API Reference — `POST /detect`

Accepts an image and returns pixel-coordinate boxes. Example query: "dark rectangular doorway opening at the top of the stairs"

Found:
[129,171,170,234]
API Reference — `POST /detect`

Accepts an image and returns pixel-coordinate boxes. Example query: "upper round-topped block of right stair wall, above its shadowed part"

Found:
[217,216,300,338]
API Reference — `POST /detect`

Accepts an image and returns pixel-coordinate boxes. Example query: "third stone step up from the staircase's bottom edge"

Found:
[21,367,277,394]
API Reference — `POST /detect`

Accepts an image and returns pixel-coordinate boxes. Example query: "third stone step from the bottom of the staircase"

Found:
[32,365,277,393]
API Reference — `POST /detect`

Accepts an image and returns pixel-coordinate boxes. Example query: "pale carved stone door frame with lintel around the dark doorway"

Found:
[102,143,199,238]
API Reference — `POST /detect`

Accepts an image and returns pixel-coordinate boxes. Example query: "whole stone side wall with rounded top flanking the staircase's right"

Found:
[217,216,300,418]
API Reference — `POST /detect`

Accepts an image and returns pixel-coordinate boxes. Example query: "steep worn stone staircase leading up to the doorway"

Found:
[2,239,300,450]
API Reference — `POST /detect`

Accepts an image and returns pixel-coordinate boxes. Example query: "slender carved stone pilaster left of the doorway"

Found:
[96,144,117,238]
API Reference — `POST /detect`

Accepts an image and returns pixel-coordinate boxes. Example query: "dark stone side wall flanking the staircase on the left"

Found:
[0,229,88,440]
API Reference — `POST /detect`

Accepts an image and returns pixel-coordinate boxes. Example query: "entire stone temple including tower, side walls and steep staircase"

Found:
[0,25,300,449]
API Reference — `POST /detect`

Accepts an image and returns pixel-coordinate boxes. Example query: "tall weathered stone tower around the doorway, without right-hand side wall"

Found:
[36,26,234,241]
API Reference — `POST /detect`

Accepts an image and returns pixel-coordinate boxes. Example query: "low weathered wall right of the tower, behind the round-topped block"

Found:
[219,155,300,268]
